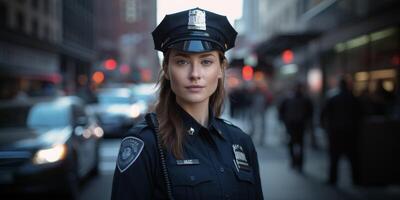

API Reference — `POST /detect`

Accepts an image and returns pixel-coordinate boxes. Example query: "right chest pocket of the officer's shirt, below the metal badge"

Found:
[233,168,256,199]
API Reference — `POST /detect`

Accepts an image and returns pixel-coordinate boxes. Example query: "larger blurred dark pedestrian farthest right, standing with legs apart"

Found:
[321,77,362,185]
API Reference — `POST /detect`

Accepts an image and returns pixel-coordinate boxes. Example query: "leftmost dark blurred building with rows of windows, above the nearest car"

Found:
[0,0,62,99]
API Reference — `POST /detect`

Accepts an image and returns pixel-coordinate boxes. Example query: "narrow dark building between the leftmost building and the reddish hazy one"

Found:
[60,0,96,94]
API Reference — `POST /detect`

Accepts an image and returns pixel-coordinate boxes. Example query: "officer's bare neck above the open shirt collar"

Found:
[177,98,209,127]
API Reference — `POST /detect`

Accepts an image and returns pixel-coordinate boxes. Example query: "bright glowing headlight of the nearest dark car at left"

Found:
[33,144,67,165]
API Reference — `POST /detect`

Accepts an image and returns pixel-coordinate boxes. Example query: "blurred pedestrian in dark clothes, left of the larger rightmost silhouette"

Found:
[278,82,313,172]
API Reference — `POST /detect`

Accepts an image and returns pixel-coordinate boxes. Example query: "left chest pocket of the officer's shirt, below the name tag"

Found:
[169,165,217,200]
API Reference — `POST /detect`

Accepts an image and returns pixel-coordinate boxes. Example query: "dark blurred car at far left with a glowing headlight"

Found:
[0,97,103,199]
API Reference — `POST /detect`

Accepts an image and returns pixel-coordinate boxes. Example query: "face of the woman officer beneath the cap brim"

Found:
[165,50,223,105]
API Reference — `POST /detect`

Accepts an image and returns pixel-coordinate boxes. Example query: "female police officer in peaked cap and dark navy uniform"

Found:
[112,8,263,200]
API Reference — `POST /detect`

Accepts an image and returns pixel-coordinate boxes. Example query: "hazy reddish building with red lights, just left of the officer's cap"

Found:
[96,0,159,82]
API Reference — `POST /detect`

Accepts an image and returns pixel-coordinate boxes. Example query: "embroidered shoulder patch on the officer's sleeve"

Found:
[117,137,144,173]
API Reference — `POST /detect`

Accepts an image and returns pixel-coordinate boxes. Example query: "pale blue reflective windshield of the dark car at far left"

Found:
[0,102,71,128]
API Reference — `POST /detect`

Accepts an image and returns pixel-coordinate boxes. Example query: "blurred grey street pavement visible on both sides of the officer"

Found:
[80,109,400,200]
